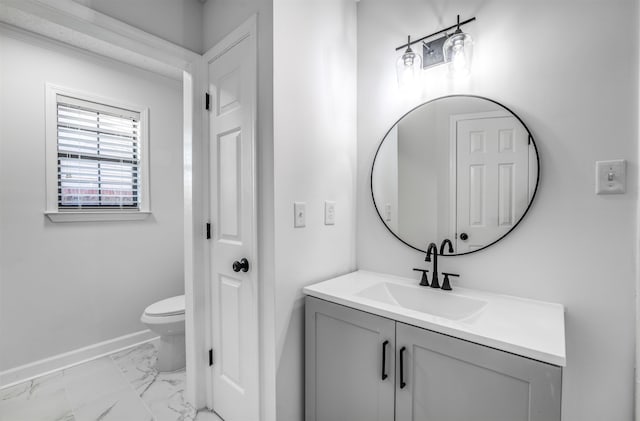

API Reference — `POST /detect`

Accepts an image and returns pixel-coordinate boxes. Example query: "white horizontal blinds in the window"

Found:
[57,95,141,210]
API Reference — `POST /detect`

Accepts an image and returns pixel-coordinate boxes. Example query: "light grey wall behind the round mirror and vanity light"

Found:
[357,0,638,421]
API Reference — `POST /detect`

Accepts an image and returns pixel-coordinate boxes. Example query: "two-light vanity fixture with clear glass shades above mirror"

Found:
[396,15,476,86]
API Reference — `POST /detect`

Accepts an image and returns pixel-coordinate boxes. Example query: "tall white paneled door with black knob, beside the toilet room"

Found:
[205,19,259,421]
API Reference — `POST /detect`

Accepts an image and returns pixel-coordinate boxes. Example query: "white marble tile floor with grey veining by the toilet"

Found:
[0,341,222,421]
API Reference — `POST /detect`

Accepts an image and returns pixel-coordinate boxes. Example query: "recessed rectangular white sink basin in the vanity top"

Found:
[356,282,487,320]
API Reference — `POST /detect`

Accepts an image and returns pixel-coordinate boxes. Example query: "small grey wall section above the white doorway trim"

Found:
[73,0,203,53]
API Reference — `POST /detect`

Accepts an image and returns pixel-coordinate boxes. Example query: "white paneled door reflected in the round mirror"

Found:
[456,114,530,253]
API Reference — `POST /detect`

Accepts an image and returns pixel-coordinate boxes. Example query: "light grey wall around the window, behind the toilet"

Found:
[0,29,183,370]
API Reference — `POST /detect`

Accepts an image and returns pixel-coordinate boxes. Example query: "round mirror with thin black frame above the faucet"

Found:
[371,95,539,255]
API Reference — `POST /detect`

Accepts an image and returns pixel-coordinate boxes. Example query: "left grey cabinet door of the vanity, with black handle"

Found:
[305,297,395,421]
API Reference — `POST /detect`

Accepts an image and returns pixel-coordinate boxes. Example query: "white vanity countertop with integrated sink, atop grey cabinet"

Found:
[303,270,566,366]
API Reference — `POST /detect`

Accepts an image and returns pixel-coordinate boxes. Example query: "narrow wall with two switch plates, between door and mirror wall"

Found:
[273,0,356,421]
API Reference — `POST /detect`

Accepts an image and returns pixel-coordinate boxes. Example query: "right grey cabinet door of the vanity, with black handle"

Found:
[396,323,562,421]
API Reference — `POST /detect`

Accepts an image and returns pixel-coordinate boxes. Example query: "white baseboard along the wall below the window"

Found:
[0,329,158,389]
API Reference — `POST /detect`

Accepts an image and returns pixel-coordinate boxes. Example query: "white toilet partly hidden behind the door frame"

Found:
[140,295,185,372]
